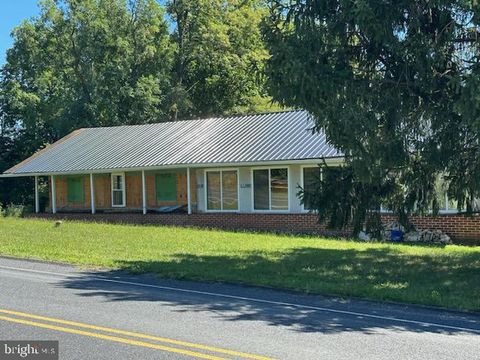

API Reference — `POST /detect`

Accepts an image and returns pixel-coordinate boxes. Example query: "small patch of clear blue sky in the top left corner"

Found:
[0,0,40,66]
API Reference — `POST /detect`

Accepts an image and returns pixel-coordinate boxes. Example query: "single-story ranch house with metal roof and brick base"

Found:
[1,110,480,239]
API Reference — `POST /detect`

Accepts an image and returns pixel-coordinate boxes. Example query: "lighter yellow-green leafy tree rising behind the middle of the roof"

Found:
[167,0,271,119]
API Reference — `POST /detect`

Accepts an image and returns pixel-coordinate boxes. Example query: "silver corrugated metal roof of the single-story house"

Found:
[5,110,341,175]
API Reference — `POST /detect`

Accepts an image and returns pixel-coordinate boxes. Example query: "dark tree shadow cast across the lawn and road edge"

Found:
[61,248,480,333]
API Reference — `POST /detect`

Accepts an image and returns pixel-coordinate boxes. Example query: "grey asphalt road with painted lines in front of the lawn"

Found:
[0,258,480,360]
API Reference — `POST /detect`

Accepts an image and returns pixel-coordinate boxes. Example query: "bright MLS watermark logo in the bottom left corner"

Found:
[0,340,58,360]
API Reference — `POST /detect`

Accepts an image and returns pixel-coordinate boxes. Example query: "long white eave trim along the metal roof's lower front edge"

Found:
[0,157,343,178]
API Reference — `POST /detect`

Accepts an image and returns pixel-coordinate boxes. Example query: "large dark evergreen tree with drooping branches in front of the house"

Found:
[264,0,480,232]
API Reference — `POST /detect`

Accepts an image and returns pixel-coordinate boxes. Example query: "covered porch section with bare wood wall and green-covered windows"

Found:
[35,168,197,214]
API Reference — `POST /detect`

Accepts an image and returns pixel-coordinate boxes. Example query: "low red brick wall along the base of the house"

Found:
[26,213,480,245]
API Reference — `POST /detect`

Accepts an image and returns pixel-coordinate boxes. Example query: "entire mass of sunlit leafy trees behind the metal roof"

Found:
[0,0,273,203]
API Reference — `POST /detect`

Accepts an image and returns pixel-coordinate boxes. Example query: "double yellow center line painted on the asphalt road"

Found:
[0,309,271,360]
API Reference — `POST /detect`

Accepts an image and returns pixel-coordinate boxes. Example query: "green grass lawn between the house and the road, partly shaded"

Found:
[0,218,480,310]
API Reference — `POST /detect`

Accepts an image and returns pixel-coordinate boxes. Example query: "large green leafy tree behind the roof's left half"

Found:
[2,0,171,141]
